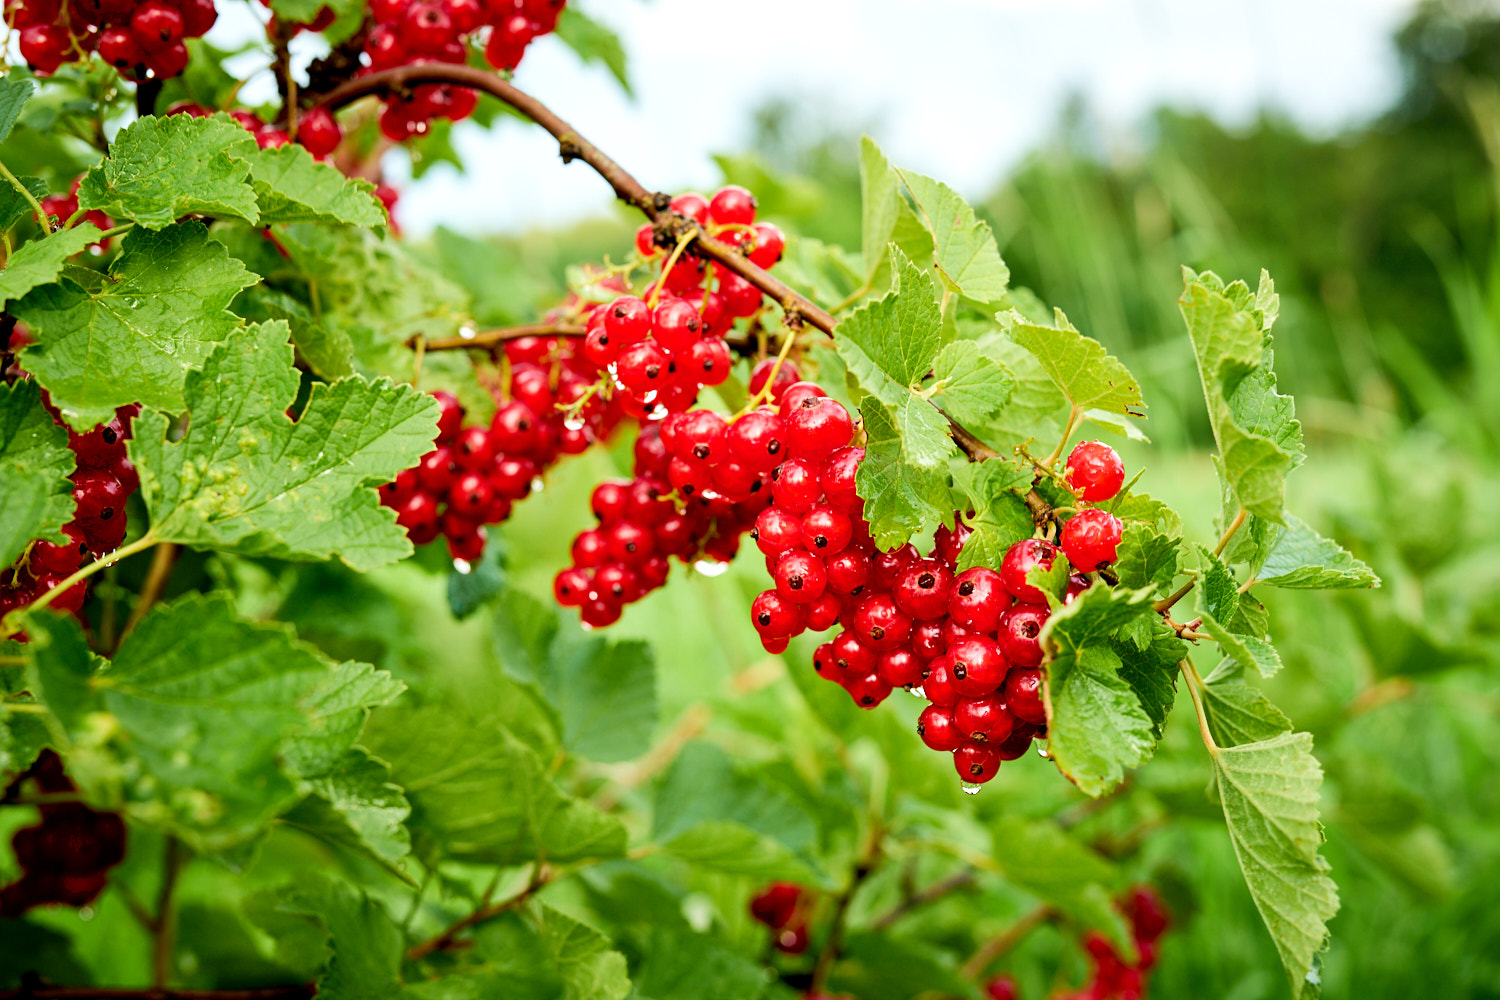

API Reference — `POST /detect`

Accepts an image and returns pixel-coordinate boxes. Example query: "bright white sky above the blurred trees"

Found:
[215,0,1415,235]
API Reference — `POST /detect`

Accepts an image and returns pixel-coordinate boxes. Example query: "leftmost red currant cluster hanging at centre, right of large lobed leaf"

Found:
[380,337,621,562]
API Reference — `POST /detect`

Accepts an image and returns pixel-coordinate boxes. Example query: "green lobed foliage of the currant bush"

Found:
[0,21,1379,1000]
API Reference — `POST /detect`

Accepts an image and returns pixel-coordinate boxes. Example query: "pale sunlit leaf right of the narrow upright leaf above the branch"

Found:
[896,168,1011,304]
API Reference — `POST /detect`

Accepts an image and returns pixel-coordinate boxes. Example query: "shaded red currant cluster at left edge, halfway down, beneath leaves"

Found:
[0,395,141,632]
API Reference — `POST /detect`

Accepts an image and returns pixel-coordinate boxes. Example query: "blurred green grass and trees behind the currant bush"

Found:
[399,4,1500,1000]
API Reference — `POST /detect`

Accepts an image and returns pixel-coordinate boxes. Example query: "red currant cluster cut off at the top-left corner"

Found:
[5,0,219,81]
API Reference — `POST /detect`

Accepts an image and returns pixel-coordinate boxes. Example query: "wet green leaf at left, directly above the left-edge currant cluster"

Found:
[11,220,255,429]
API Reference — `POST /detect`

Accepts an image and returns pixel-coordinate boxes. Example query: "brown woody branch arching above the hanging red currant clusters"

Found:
[321,63,834,334]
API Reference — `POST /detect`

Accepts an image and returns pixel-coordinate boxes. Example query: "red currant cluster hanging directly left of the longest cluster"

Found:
[552,358,797,628]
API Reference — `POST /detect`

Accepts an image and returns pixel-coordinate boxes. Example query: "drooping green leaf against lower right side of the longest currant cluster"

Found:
[1041,586,1155,798]
